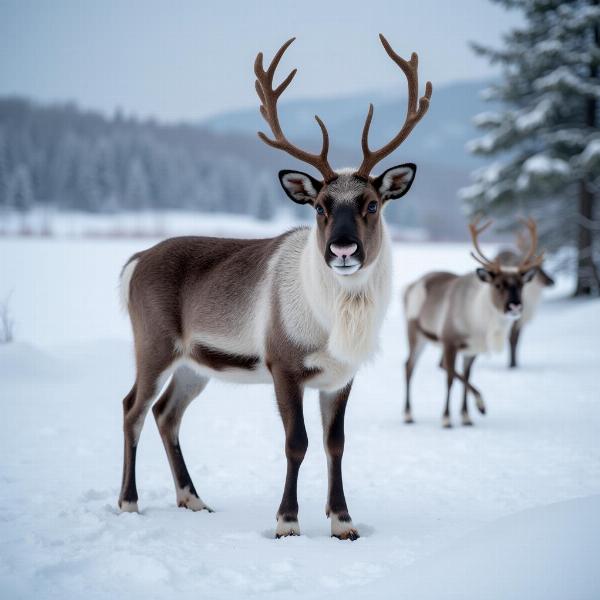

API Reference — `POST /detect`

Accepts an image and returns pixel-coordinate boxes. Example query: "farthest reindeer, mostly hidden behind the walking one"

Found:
[495,235,554,369]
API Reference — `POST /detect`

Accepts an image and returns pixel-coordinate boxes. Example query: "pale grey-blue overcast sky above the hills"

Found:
[0,0,519,120]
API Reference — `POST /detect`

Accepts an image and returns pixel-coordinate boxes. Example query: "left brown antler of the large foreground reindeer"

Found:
[254,38,336,182]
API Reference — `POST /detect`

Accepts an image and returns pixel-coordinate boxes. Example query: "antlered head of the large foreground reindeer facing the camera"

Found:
[254,34,432,275]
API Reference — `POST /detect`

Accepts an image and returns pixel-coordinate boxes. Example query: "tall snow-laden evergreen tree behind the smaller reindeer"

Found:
[461,0,600,295]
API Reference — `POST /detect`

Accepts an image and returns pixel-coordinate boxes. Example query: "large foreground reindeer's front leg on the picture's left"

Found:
[271,368,308,538]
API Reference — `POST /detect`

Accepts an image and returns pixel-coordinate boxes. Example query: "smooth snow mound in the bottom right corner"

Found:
[369,496,600,600]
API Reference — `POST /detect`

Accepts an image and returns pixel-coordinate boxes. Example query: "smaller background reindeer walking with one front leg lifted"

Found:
[404,219,543,427]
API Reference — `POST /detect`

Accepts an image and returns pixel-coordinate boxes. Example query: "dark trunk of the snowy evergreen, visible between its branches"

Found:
[575,0,600,296]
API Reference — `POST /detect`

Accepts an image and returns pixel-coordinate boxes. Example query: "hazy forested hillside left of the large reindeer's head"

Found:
[0,98,281,218]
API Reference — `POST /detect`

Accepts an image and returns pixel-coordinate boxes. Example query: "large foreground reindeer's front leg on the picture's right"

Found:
[319,382,360,540]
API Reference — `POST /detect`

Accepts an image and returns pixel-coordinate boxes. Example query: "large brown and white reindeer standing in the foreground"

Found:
[119,36,432,539]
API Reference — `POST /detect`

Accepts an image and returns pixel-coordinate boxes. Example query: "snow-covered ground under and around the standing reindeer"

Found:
[0,239,600,600]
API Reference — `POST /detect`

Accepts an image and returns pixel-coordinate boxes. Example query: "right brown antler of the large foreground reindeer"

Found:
[356,33,433,179]
